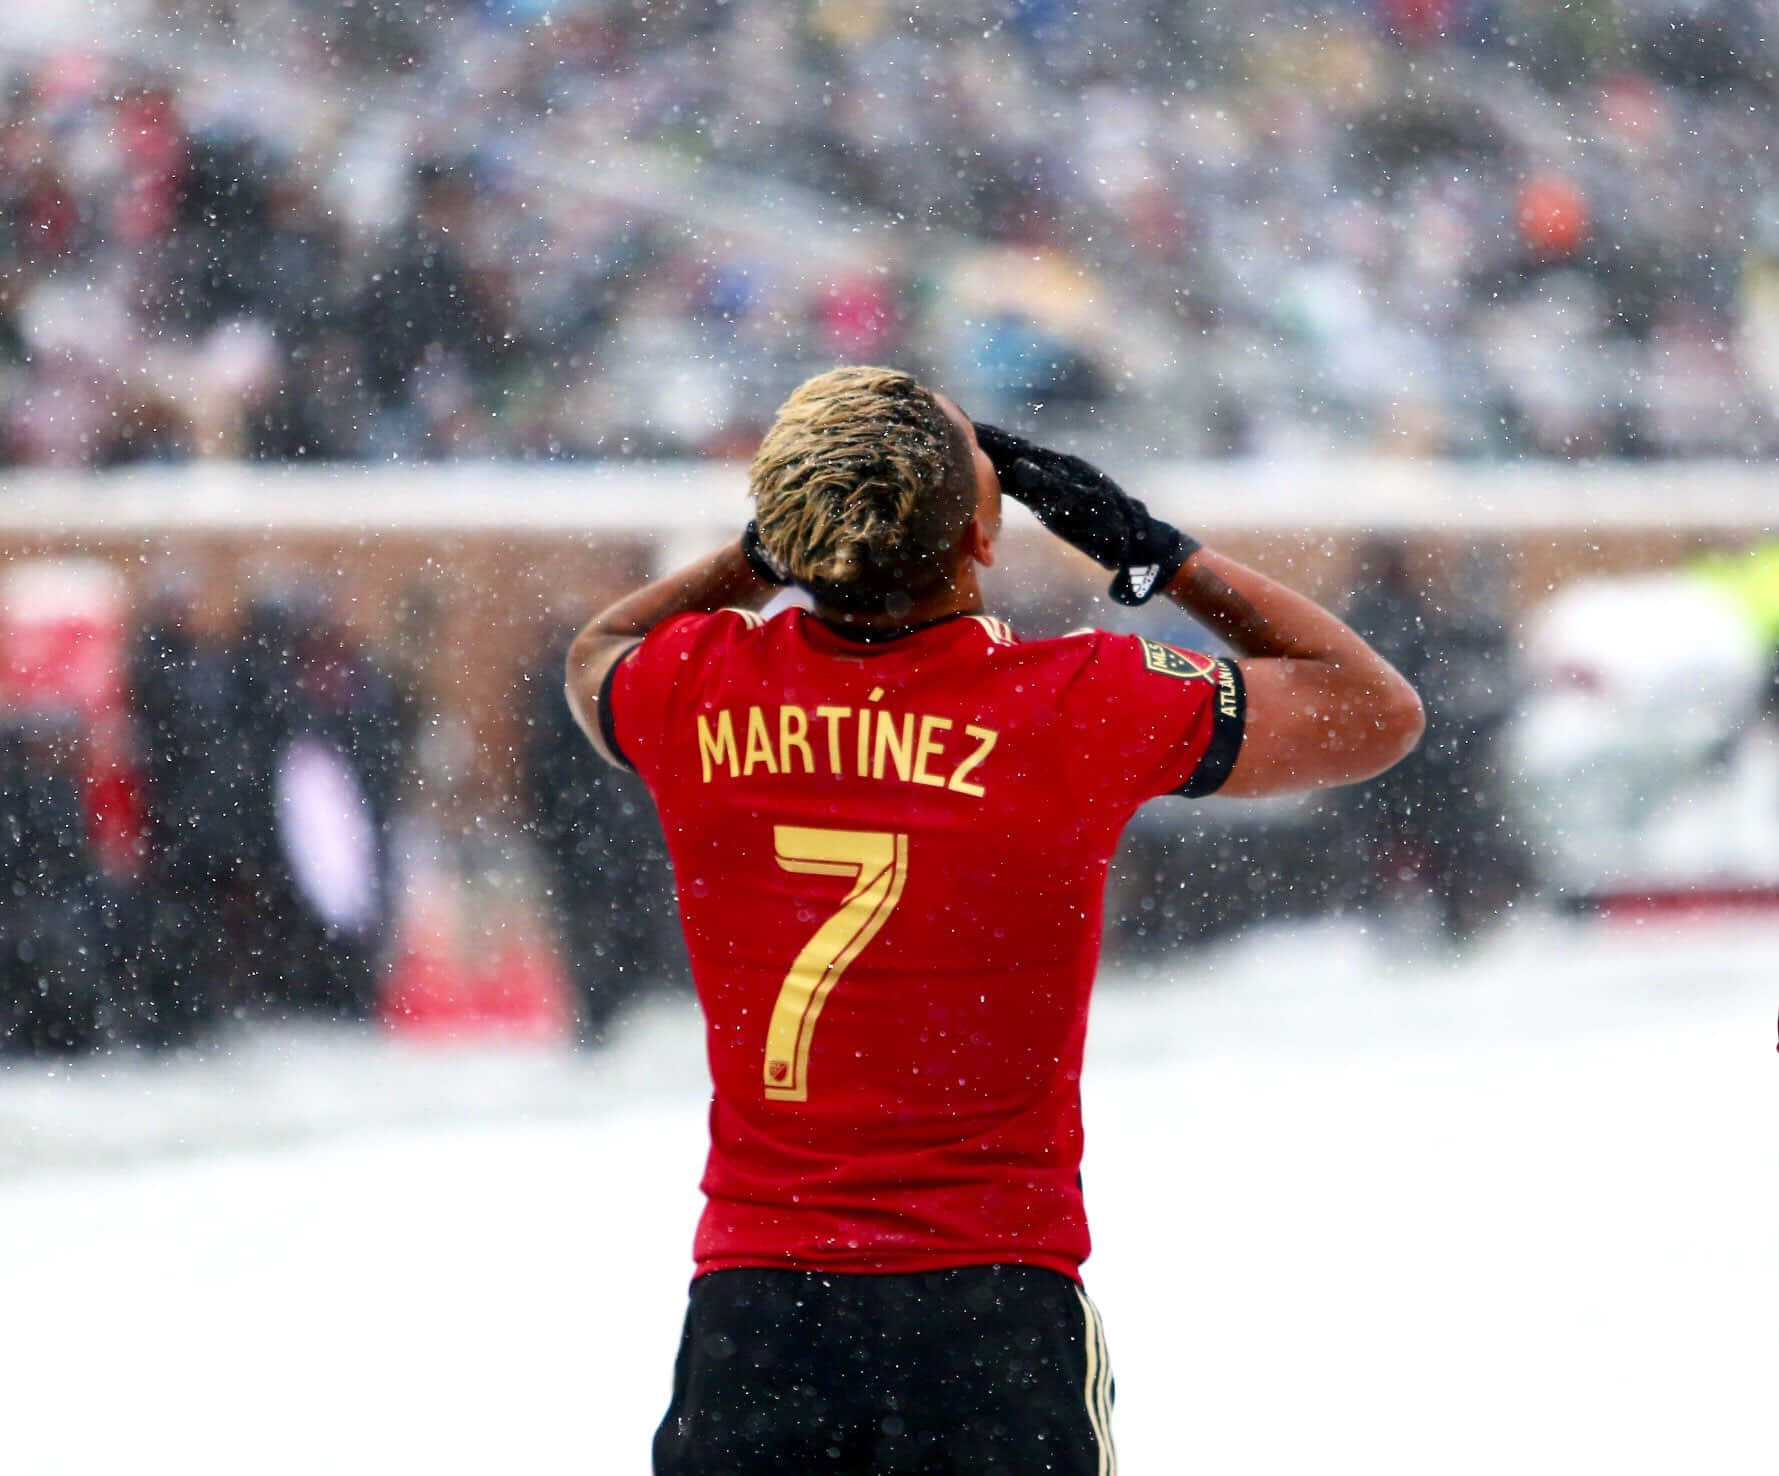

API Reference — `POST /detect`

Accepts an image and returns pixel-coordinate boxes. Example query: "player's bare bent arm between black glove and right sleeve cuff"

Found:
[1167,548,1427,795]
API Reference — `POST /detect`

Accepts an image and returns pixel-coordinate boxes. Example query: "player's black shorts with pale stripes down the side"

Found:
[655,1266,1117,1476]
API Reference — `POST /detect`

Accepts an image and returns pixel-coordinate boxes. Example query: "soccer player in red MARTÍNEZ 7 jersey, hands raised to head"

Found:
[568,368,1421,1476]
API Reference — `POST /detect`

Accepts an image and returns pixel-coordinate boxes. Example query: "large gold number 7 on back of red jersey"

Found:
[765,825,907,1103]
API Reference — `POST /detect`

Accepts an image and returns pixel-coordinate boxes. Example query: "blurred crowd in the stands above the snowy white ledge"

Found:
[0,0,1779,466]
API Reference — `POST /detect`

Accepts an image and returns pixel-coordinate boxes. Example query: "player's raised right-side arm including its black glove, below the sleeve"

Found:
[977,425,1425,797]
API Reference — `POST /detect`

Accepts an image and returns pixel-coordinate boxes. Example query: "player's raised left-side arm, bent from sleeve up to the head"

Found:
[566,523,785,763]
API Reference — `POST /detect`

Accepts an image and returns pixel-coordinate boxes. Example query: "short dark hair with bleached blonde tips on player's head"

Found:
[747,365,977,612]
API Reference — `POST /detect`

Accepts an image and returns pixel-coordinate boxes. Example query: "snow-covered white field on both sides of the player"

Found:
[0,919,1779,1476]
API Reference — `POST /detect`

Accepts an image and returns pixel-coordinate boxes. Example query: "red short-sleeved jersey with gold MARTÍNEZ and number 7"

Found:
[600,610,1242,1277]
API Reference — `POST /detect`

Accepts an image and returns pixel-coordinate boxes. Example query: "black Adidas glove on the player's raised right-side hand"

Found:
[977,425,1201,605]
